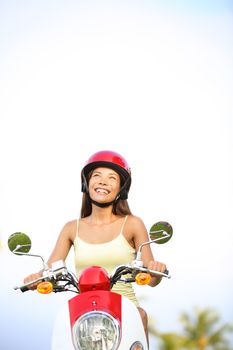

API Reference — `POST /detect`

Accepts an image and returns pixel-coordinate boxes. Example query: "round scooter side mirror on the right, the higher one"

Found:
[149,221,173,244]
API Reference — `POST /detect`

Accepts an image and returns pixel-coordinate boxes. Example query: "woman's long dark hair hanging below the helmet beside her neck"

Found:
[81,193,132,218]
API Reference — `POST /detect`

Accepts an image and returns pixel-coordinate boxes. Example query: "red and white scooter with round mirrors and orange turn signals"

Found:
[8,221,173,350]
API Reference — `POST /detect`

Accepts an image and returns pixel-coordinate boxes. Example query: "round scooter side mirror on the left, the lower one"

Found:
[8,232,32,255]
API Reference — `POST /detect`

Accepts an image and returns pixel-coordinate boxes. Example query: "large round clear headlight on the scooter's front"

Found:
[72,311,120,350]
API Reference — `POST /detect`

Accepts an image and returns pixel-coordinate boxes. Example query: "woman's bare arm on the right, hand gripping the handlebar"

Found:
[130,216,166,287]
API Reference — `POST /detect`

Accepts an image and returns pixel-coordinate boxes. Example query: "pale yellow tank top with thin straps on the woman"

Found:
[74,216,139,306]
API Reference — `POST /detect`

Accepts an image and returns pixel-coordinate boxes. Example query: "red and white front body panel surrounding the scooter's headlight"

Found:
[51,291,148,350]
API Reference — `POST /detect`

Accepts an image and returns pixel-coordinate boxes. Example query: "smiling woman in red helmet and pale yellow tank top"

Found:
[24,151,166,344]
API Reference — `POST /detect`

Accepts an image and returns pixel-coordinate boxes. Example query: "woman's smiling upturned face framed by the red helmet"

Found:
[89,168,120,203]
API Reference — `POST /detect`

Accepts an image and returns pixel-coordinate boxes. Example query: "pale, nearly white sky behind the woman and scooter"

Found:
[0,0,233,350]
